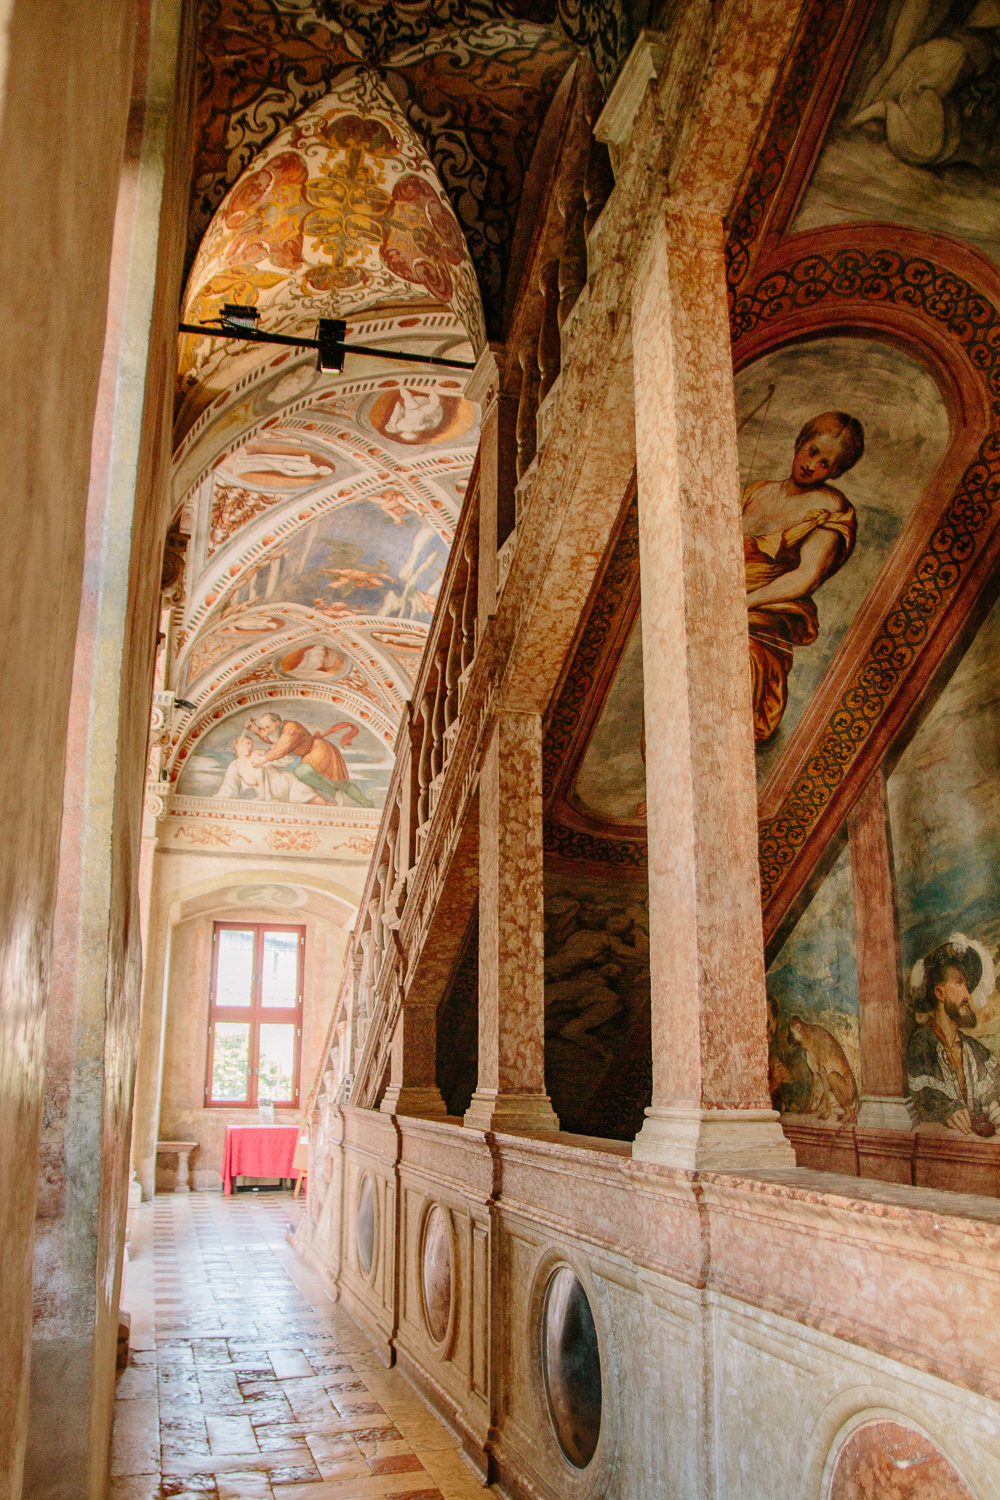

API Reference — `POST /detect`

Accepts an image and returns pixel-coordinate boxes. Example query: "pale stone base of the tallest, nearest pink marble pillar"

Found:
[633,1106,795,1172]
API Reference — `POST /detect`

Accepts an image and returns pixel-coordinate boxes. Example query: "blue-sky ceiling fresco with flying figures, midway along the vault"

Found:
[203,500,447,621]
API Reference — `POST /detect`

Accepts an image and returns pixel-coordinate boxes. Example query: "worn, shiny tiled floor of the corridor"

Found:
[109,1193,492,1500]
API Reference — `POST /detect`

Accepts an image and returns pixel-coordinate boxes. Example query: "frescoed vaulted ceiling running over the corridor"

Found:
[165,0,643,806]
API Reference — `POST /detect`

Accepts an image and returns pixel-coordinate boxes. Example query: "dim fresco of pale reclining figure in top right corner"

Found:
[795,0,1000,261]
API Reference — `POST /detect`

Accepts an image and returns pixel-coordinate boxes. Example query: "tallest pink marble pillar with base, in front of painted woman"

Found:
[633,203,795,1170]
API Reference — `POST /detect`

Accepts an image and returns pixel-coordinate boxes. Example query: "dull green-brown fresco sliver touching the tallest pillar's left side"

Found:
[570,618,646,824]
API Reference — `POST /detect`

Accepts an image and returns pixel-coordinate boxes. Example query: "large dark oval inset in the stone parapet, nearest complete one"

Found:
[541,1266,601,1469]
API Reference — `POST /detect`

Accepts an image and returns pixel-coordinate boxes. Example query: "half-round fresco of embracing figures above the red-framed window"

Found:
[177,698,391,807]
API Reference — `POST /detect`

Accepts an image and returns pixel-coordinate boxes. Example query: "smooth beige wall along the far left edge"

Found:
[0,0,142,1500]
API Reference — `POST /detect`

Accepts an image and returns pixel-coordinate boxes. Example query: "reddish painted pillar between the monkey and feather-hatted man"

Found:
[847,770,913,1134]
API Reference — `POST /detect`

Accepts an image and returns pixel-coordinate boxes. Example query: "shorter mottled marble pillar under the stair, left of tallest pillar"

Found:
[465,708,559,1131]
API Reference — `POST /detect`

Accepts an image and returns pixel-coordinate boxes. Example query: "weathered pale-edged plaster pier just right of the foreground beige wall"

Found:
[25,0,189,1500]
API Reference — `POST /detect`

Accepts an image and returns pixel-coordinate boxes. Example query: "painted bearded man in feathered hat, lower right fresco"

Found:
[906,938,1000,1136]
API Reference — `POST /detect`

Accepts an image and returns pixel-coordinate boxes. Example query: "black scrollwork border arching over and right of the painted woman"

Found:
[733,246,1000,905]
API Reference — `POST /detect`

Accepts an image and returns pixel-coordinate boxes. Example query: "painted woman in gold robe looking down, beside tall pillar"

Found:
[744,411,865,744]
